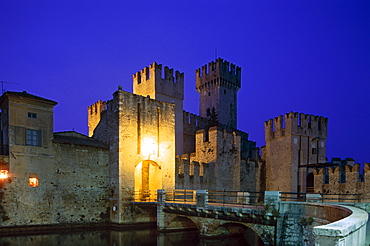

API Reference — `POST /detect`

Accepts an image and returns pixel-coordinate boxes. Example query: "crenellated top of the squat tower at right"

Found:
[264,112,328,141]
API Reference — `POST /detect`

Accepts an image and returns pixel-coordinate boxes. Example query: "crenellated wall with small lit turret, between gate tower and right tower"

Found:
[176,126,262,191]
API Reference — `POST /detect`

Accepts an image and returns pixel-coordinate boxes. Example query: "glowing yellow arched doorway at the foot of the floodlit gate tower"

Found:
[135,160,162,200]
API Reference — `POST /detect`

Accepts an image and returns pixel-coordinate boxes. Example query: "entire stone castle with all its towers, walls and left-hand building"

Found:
[0,58,370,227]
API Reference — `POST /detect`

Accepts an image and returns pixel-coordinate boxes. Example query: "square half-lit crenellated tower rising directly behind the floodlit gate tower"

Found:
[132,62,184,155]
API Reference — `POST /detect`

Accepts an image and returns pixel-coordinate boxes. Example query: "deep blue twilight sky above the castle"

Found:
[0,0,370,163]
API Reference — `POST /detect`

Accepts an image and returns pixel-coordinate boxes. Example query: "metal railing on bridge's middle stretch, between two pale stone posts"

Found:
[208,191,264,207]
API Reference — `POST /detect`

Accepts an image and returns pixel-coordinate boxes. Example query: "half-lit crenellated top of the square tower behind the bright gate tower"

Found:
[132,62,184,100]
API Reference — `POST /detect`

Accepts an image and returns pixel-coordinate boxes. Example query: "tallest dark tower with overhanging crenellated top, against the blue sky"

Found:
[195,58,241,128]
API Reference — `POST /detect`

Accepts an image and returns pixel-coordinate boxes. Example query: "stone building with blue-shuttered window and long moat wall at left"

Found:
[0,91,109,227]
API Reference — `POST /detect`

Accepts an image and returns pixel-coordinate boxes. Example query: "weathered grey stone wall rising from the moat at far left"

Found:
[0,140,109,226]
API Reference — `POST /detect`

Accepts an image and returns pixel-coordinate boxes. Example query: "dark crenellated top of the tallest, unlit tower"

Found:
[195,58,241,92]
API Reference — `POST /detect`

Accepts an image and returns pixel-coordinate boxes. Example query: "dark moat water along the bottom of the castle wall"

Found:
[0,229,263,246]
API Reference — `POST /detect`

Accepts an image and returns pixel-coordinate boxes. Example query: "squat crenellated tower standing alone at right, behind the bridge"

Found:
[265,112,328,192]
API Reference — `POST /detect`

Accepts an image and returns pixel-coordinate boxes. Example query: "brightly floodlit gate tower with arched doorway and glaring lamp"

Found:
[93,87,175,223]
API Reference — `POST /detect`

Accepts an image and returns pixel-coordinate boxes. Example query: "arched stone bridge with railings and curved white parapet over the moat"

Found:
[150,190,368,246]
